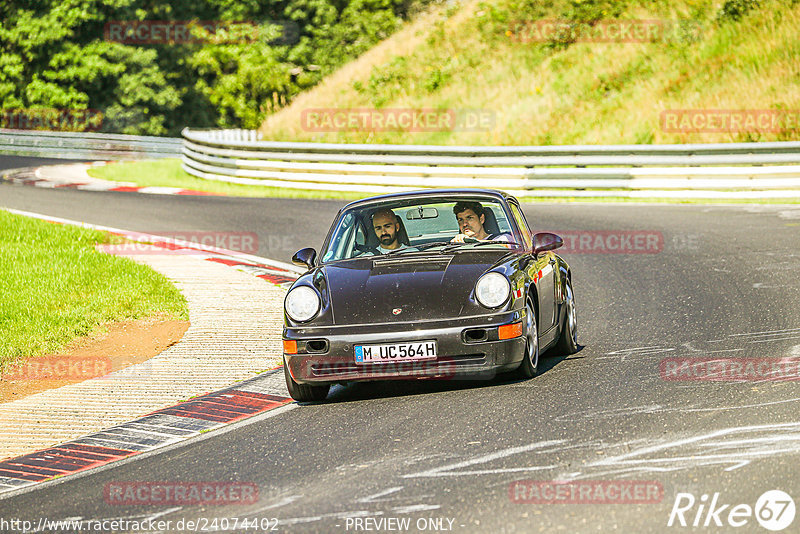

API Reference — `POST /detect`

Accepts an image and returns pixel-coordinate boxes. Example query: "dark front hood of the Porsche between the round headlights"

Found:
[323,250,506,325]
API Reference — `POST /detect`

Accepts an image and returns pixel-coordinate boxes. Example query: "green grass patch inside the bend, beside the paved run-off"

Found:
[0,210,188,372]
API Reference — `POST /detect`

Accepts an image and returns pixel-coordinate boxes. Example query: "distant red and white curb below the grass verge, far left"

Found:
[0,162,225,196]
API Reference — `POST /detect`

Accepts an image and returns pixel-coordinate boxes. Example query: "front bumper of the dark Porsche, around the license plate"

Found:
[283,310,525,384]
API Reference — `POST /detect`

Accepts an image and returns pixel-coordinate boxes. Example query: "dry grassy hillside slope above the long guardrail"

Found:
[261,0,800,145]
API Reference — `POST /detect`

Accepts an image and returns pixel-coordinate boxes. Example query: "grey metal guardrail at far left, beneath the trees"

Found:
[0,129,182,160]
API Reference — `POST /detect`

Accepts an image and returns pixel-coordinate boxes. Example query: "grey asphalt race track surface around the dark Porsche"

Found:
[0,160,800,532]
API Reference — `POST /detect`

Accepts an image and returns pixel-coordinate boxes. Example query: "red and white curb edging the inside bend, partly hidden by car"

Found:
[0,209,301,495]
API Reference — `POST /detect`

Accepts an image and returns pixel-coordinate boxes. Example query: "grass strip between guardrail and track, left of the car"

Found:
[89,158,373,200]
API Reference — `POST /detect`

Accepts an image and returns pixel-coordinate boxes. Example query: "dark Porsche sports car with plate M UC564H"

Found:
[283,189,578,401]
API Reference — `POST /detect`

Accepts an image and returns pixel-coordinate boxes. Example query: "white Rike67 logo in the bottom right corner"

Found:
[667,490,795,532]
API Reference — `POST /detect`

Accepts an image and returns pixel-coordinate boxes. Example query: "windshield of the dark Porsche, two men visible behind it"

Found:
[322,197,518,262]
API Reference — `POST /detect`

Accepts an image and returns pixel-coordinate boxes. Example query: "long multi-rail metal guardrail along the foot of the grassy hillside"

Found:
[182,128,800,197]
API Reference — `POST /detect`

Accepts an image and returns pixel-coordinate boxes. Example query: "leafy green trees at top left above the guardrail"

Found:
[0,0,429,135]
